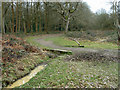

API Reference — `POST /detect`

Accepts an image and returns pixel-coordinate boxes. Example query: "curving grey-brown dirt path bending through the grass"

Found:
[36,34,118,57]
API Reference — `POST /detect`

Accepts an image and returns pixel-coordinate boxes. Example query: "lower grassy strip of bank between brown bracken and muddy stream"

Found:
[2,53,50,86]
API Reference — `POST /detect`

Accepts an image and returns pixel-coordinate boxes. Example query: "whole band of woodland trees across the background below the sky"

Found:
[2,0,114,33]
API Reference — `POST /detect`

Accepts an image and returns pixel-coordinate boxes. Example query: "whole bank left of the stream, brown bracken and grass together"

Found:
[1,34,50,87]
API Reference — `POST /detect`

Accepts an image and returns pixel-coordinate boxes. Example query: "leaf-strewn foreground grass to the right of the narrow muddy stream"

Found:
[17,57,118,88]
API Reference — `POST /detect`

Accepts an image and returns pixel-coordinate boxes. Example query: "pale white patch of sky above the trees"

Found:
[83,0,117,13]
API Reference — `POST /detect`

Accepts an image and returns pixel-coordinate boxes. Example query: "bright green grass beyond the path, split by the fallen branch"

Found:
[45,36,118,49]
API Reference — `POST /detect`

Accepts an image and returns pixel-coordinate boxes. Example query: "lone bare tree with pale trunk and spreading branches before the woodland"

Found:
[51,2,79,33]
